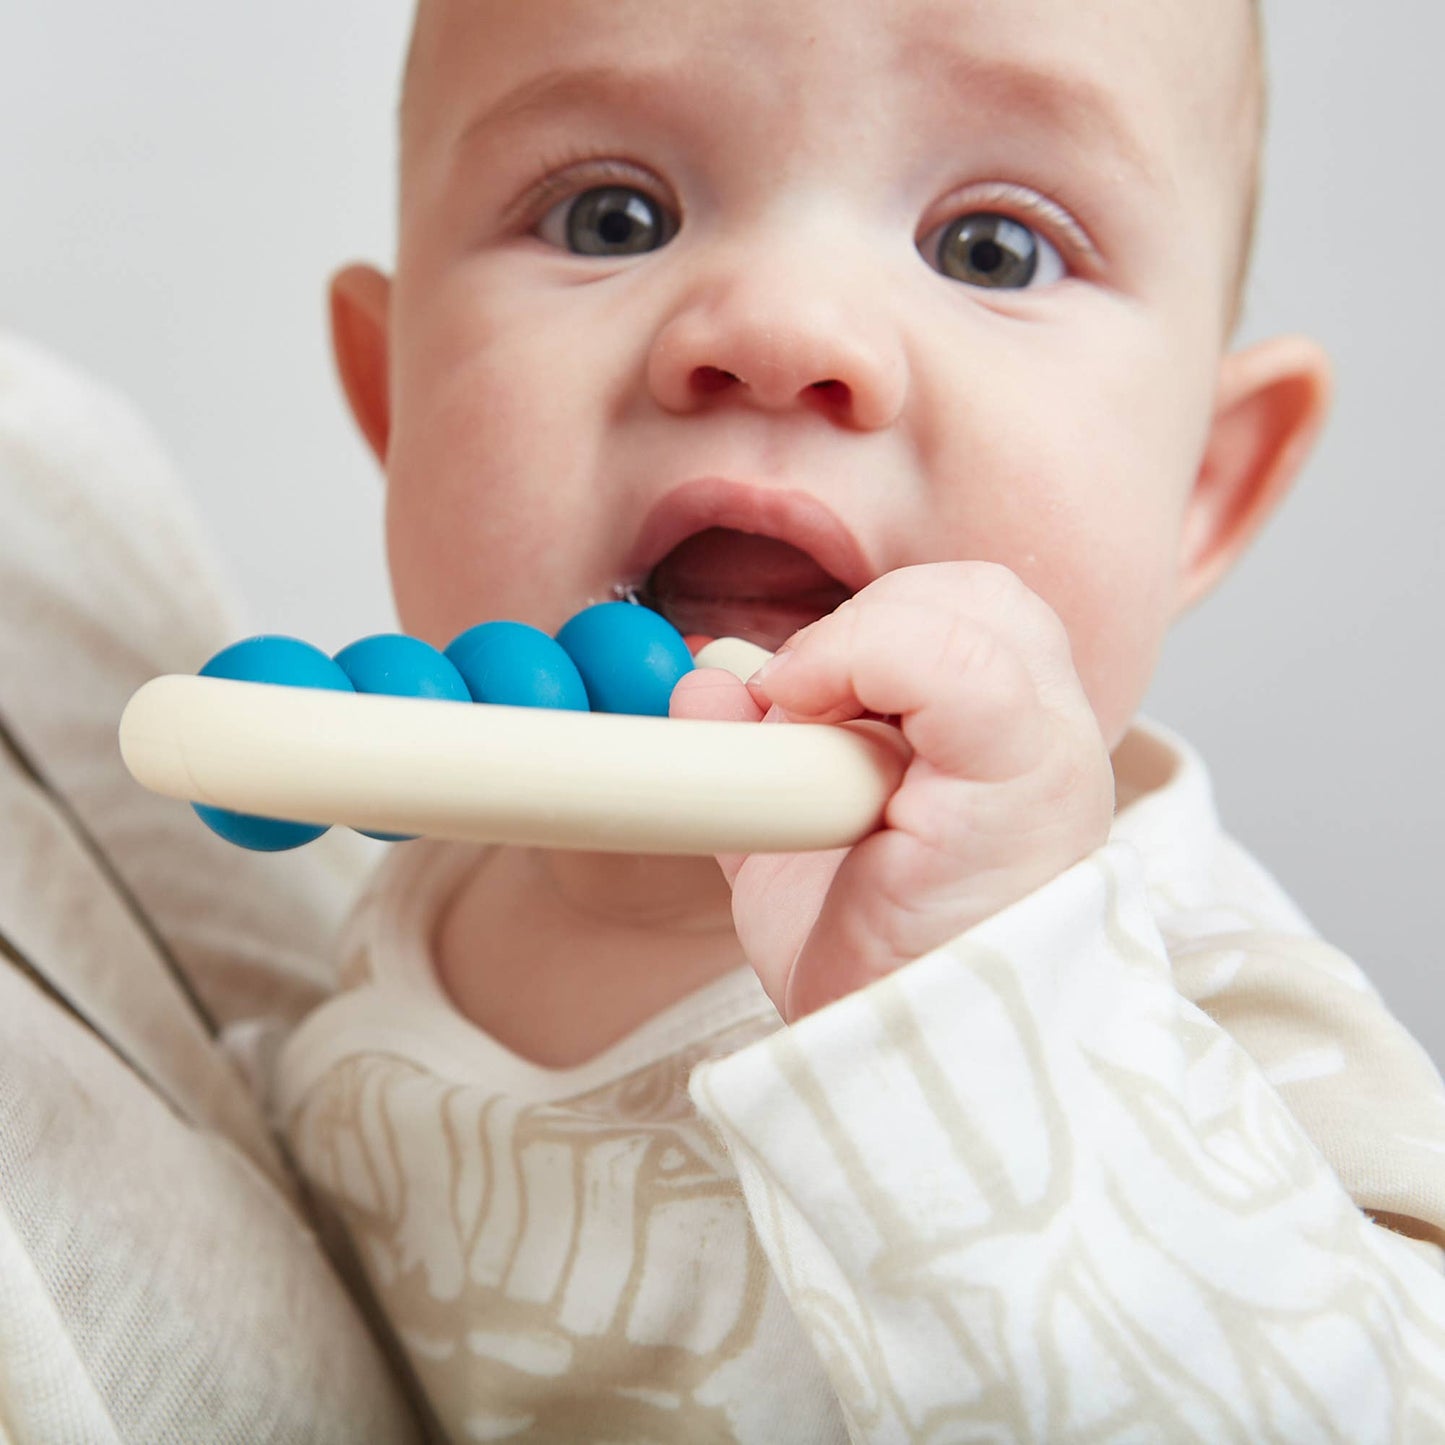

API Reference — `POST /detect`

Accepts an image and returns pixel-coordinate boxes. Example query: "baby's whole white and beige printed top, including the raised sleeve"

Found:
[276,725,1445,1445]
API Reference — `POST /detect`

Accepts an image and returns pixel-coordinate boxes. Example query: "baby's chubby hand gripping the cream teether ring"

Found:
[672,562,1114,1022]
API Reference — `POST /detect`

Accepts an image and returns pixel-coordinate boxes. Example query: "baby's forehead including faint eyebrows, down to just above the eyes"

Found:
[402,0,1260,277]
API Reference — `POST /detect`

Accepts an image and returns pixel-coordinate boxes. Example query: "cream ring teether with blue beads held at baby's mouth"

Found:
[120,603,909,854]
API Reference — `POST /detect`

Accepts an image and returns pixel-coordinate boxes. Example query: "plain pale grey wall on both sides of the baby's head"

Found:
[0,0,1445,1061]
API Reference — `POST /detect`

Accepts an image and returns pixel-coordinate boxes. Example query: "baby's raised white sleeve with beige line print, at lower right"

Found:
[692,842,1445,1445]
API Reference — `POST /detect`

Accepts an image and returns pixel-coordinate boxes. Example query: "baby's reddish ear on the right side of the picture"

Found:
[1176,337,1332,613]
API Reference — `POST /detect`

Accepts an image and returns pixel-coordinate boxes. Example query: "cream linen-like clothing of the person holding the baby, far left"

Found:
[0,335,422,1445]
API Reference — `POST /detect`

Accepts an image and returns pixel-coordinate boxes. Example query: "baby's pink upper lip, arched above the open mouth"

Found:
[626,477,877,592]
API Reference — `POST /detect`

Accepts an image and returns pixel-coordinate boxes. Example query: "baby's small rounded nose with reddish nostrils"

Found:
[647,260,906,431]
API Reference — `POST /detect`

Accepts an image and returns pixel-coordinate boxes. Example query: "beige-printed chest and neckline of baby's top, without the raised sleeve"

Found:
[282,841,844,1442]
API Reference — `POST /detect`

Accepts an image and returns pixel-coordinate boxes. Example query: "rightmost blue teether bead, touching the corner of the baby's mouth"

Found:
[556,603,692,718]
